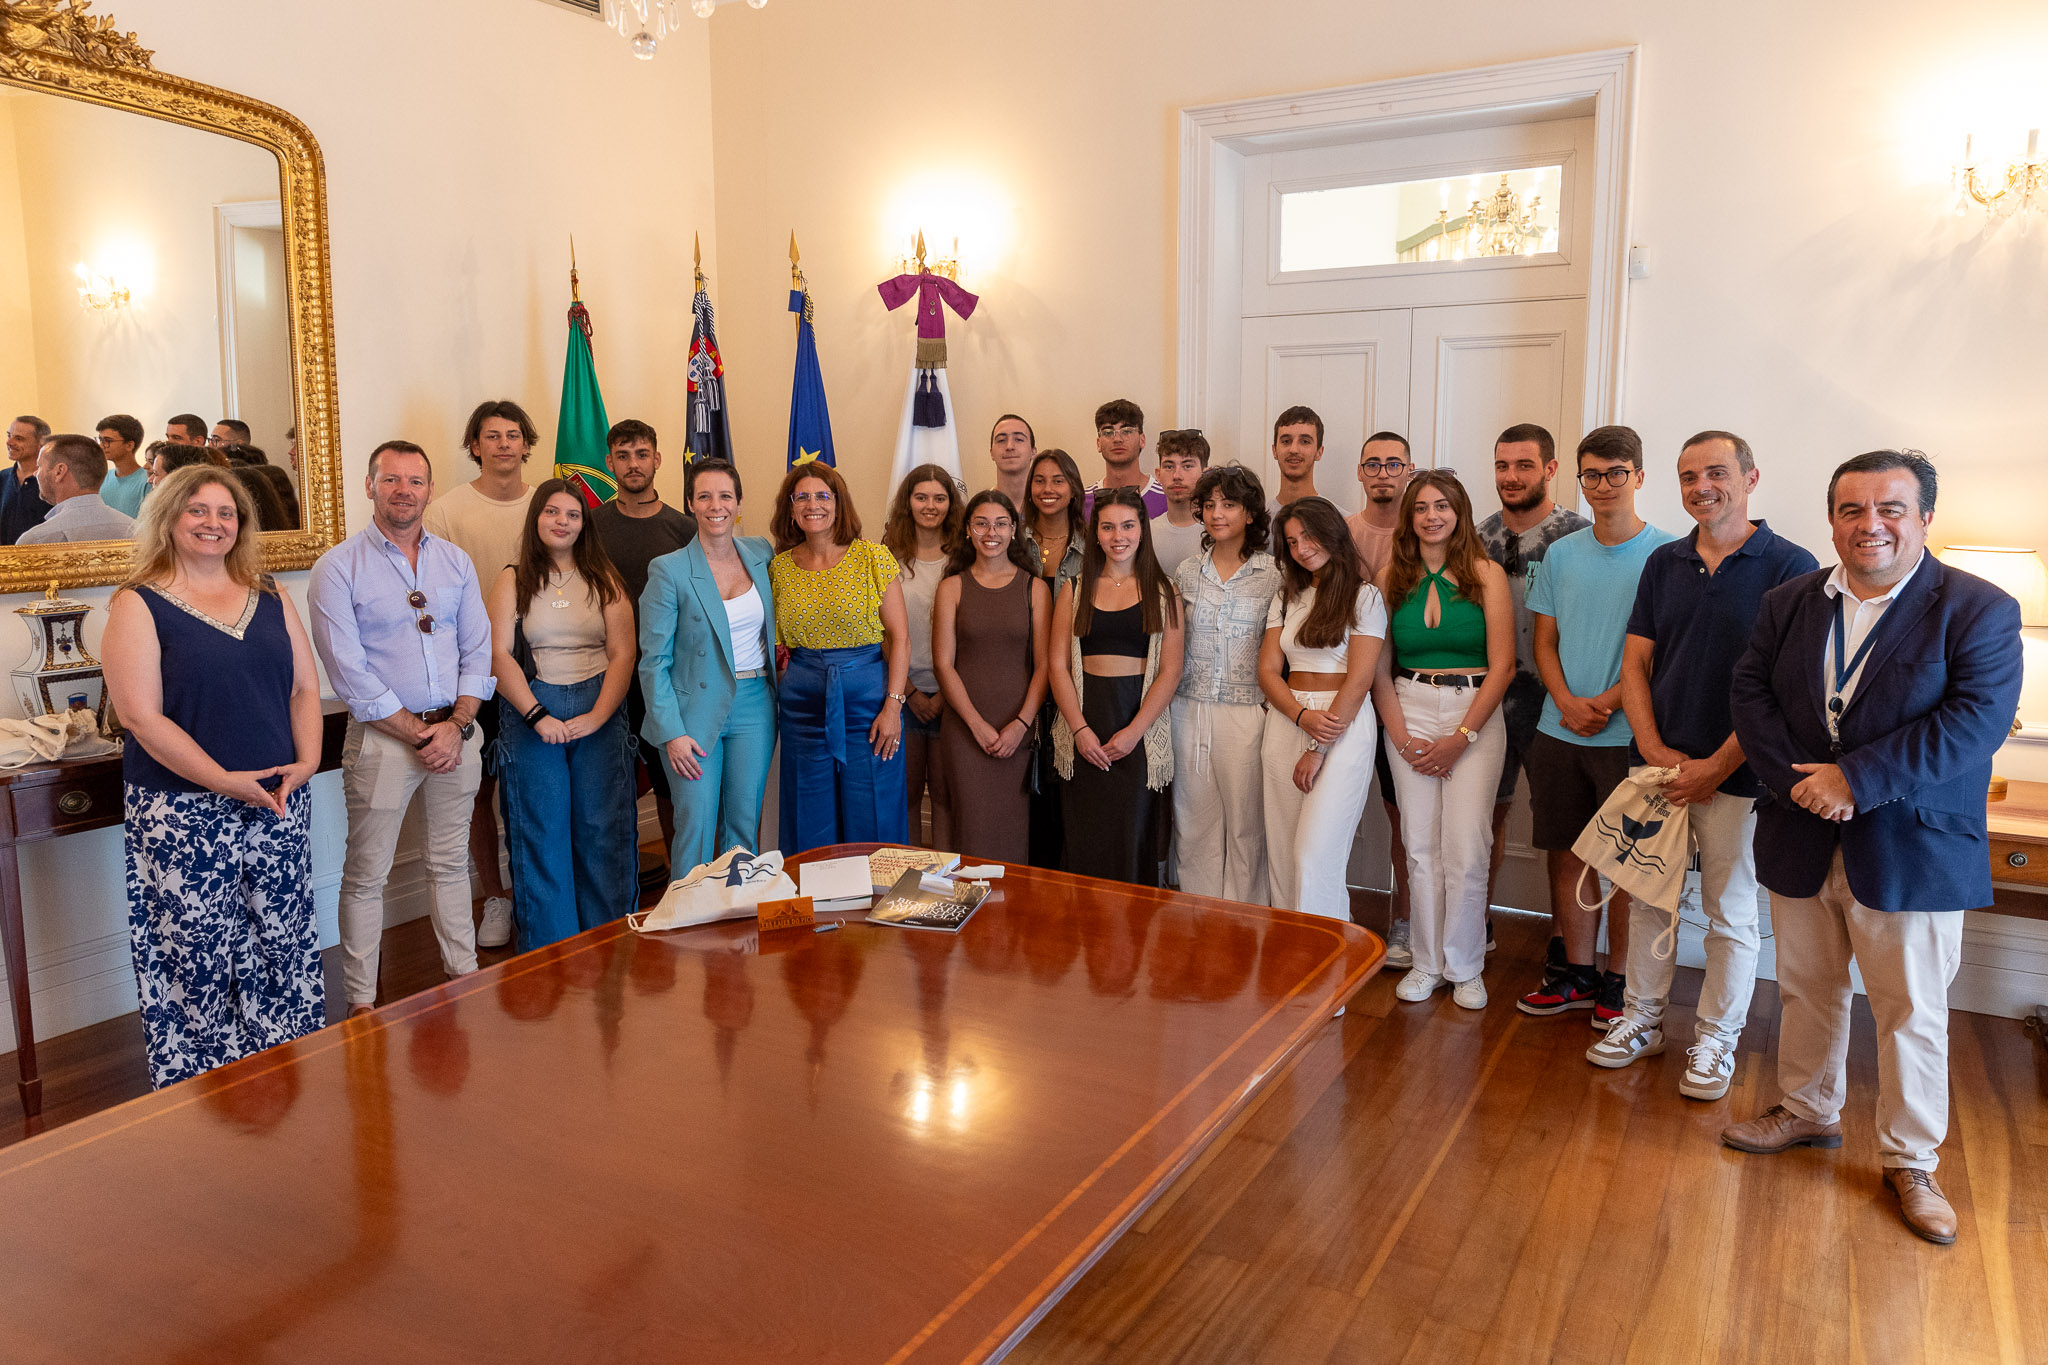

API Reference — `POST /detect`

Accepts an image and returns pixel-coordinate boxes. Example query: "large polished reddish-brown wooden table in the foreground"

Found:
[0,849,1382,1365]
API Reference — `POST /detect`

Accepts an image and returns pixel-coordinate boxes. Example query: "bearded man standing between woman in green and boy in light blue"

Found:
[1479,422,1591,970]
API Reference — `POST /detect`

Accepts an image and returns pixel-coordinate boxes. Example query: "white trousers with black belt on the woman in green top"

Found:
[1386,677,1507,982]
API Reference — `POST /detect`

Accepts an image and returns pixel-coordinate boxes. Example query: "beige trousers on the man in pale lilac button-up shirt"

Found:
[340,718,483,1005]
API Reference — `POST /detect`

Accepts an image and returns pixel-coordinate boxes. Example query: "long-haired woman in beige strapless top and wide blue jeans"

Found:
[489,479,639,952]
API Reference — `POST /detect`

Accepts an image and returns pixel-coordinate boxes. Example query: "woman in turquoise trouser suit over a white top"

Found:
[639,460,776,876]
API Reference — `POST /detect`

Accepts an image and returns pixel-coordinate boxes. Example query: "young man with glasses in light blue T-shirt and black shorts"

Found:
[1520,426,1675,1029]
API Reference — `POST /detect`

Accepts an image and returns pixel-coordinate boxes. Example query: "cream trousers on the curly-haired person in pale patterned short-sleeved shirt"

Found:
[1174,698,1268,905]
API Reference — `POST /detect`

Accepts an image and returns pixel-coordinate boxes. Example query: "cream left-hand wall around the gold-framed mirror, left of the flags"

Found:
[0,0,717,1050]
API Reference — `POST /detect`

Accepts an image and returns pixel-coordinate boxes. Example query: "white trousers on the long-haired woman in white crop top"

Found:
[1261,692,1378,921]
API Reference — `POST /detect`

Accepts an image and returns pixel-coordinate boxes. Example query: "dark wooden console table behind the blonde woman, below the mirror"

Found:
[0,702,348,1117]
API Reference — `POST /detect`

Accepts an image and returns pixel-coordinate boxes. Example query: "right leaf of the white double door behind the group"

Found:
[1407,299,1585,520]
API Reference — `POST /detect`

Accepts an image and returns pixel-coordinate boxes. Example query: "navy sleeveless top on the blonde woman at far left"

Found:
[121,587,299,792]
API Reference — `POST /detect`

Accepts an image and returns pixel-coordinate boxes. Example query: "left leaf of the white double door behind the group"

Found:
[1233,309,1411,516]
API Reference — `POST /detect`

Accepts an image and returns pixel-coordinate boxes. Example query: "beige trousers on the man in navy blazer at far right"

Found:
[1772,849,1962,1171]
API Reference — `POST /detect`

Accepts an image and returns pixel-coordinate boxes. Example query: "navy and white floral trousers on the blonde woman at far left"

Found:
[125,782,328,1087]
